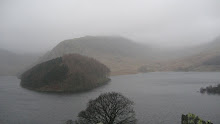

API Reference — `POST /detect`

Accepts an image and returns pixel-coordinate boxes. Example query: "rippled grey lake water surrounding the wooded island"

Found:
[0,72,220,124]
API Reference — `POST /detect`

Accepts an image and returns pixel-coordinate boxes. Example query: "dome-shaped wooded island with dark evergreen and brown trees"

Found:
[21,54,110,92]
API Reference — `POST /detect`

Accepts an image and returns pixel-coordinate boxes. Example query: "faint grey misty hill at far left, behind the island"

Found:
[0,48,39,76]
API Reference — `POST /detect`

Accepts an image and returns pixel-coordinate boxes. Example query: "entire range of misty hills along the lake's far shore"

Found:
[0,36,220,75]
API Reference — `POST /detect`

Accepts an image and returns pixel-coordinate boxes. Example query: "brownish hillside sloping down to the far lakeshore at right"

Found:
[138,37,220,72]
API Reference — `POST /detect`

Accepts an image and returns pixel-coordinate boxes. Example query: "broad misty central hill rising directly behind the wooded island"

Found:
[40,36,154,75]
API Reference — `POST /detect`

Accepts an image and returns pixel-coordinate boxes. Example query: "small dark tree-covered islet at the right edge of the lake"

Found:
[200,84,220,94]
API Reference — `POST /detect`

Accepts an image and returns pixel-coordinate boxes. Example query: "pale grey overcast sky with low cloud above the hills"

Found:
[0,0,220,52]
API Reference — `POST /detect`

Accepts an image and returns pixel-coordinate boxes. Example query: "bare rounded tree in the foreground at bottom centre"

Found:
[76,92,137,124]
